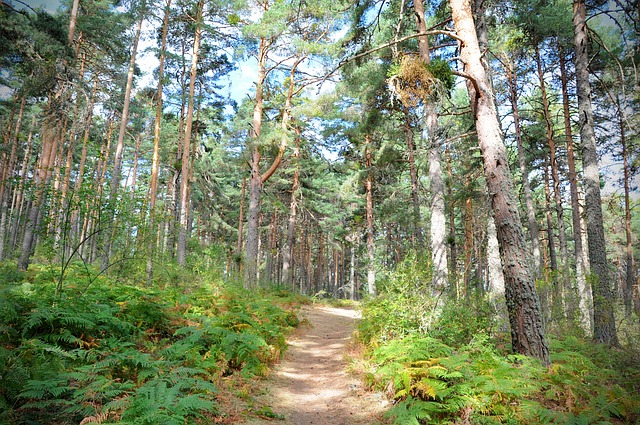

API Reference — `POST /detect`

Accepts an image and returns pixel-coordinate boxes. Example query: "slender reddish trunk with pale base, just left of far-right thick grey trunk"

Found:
[559,48,592,334]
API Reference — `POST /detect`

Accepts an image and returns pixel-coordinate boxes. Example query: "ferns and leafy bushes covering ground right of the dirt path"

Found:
[357,255,640,425]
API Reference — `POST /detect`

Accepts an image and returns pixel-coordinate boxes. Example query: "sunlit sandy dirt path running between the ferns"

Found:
[245,307,389,425]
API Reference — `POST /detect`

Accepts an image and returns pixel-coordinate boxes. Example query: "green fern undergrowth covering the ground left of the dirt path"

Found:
[0,260,298,424]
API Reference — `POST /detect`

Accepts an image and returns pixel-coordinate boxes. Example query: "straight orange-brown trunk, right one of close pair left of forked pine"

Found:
[178,0,204,266]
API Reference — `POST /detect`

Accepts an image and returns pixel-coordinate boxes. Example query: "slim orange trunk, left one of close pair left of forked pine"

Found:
[147,0,171,285]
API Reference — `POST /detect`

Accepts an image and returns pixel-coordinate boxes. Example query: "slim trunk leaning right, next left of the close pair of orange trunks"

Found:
[100,13,145,271]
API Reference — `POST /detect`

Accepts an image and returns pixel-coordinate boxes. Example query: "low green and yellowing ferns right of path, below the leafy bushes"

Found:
[364,307,640,424]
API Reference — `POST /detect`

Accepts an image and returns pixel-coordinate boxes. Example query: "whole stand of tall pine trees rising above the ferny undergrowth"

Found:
[0,0,640,362]
